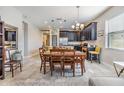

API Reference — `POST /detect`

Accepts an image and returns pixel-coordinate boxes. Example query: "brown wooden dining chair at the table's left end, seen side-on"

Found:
[39,48,50,74]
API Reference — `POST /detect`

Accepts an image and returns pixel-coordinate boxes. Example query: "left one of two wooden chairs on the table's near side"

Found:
[50,49,63,76]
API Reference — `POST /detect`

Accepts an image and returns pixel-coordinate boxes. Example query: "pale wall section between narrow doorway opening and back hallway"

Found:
[28,22,42,56]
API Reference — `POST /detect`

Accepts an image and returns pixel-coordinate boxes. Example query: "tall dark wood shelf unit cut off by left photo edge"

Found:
[0,21,4,79]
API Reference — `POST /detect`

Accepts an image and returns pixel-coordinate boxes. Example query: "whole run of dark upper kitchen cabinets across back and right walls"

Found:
[60,22,97,42]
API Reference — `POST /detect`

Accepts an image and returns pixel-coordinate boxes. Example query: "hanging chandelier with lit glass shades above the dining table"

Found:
[71,6,84,31]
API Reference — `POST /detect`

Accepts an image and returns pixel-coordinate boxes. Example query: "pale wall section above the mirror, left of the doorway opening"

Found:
[0,7,24,53]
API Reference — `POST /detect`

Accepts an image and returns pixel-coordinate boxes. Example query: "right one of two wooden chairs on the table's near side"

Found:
[63,49,75,76]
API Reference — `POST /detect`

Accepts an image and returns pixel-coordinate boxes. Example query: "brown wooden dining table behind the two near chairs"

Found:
[43,51,86,74]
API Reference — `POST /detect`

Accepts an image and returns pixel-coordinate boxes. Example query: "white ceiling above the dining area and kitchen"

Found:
[16,6,109,29]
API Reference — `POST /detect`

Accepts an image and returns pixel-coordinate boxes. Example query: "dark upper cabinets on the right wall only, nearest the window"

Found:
[80,22,97,41]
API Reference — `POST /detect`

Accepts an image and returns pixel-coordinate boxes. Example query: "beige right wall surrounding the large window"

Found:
[86,6,124,64]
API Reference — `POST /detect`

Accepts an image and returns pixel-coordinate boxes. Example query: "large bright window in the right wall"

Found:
[106,14,124,50]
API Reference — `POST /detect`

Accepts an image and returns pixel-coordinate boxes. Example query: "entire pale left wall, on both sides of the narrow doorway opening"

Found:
[0,6,42,56]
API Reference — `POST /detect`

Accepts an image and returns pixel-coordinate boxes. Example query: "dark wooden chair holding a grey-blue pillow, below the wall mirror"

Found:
[4,49,22,77]
